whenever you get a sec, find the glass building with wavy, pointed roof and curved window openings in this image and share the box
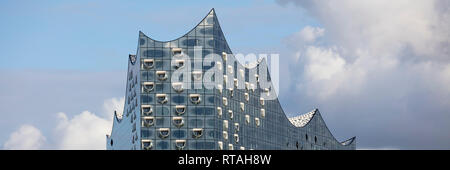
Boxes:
[106,9,355,150]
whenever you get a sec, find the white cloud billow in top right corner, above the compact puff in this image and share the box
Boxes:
[279,0,450,61]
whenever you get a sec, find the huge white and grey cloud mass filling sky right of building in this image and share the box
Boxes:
[278,0,450,148]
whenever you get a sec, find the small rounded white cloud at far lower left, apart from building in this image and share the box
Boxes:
[3,125,46,150]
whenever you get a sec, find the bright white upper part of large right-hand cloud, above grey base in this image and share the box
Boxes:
[278,0,450,99]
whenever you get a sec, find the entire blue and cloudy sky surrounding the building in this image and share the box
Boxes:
[0,0,450,149]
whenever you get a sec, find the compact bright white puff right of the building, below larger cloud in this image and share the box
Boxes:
[298,46,365,100]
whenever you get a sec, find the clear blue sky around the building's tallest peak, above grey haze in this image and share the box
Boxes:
[0,1,314,71]
